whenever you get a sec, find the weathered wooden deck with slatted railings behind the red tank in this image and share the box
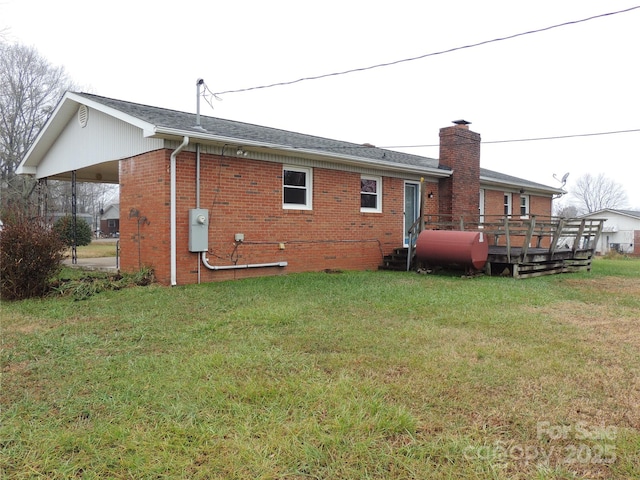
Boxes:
[408,215,605,278]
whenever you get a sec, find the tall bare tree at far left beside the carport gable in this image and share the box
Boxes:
[0,41,72,212]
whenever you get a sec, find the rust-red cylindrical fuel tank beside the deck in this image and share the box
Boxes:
[416,230,489,270]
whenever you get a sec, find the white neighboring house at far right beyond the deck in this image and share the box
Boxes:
[578,208,640,255]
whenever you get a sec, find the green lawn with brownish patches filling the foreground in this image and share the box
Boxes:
[0,259,640,479]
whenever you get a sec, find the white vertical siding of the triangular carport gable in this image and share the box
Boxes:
[37,108,164,178]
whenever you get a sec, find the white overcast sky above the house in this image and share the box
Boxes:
[5,0,640,210]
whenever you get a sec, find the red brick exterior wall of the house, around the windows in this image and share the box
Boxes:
[120,150,438,284]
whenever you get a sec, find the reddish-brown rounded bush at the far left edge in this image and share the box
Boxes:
[0,212,65,300]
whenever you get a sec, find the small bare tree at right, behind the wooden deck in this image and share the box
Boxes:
[571,173,627,213]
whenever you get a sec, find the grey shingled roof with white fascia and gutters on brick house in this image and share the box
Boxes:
[18,92,563,195]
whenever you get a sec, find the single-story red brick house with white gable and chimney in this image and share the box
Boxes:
[18,92,563,285]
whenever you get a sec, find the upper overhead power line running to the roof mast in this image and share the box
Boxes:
[213,5,640,97]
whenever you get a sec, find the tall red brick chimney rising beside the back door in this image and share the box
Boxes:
[439,120,480,222]
